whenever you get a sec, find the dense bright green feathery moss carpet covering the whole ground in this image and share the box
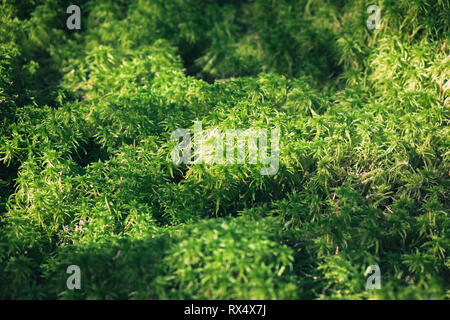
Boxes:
[0,0,450,299]
